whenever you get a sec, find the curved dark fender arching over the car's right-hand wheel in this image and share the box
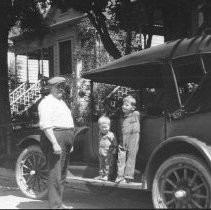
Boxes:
[143,136,211,189]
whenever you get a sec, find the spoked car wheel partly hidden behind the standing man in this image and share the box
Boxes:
[15,145,48,199]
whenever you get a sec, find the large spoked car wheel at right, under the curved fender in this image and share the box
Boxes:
[152,154,211,208]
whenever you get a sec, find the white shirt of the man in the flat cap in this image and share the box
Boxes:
[38,94,74,130]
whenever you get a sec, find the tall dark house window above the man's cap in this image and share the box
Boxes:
[59,40,72,75]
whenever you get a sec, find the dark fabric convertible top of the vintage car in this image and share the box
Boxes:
[83,35,211,88]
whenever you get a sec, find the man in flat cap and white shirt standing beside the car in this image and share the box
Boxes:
[38,77,74,209]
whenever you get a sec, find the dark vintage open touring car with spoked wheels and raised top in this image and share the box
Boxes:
[16,36,211,208]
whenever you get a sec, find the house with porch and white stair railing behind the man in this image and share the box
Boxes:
[10,7,85,113]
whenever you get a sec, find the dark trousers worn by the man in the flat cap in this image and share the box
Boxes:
[40,130,73,209]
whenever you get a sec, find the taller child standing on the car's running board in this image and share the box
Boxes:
[115,95,140,183]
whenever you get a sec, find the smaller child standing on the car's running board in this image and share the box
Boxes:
[95,116,117,181]
